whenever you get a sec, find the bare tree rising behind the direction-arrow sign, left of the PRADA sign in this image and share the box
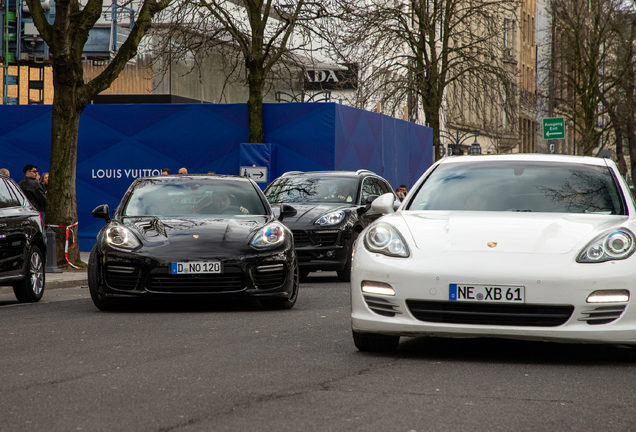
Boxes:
[152,0,325,143]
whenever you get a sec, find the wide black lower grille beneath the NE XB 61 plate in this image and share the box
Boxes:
[406,300,574,327]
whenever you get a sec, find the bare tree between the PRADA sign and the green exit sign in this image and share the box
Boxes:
[320,0,519,158]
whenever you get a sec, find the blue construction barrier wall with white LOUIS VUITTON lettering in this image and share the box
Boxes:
[0,103,433,251]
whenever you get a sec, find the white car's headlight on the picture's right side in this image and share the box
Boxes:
[576,228,636,263]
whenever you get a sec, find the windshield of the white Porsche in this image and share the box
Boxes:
[408,161,626,215]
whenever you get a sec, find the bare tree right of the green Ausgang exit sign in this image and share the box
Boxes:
[546,0,626,156]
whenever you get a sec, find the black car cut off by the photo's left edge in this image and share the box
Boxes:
[0,174,46,302]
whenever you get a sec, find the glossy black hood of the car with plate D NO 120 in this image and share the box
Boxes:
[118,216,267,254]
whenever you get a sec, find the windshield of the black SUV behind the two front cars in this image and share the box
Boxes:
[265,177,358,204]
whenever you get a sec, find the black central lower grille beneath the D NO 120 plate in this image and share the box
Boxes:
[146,271,247,294]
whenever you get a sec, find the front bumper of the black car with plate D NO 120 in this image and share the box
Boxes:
[98,249,294,298]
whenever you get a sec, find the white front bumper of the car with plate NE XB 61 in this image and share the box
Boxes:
[351,244,636,345]
